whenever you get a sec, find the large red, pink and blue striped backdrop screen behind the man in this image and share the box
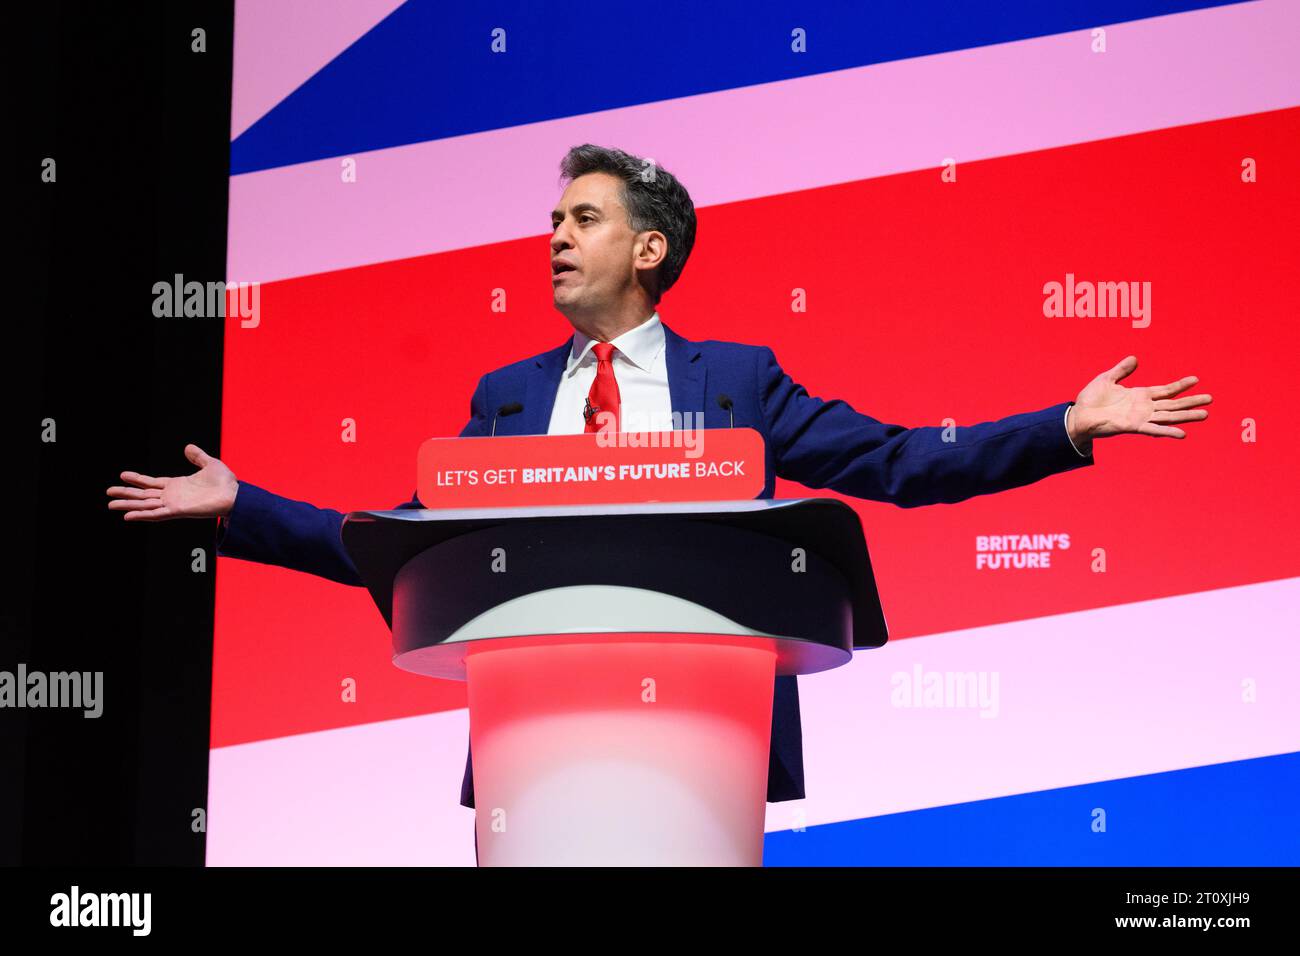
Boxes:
[208,0,1300,865]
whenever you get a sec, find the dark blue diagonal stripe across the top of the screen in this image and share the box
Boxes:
[230,0,1240,174]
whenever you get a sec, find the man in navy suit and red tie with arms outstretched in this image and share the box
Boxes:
[108,144,1210,868]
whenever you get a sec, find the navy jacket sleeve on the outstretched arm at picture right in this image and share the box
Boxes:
[757,347,1093,507]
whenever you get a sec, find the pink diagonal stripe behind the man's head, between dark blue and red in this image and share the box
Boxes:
[228,0,1300,282]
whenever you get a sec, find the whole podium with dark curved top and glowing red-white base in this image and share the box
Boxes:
[342,494,888,866]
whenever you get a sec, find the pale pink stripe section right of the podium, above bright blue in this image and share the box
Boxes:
[767,578,1300,830]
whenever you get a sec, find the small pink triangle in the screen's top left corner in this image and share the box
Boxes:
[230,0,403,139]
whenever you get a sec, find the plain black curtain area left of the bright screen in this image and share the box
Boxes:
[0,0,234,865]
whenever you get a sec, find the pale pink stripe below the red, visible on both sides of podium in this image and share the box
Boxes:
[208,578,1300,866]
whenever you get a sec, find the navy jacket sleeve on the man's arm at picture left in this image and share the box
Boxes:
[217,376,488,587]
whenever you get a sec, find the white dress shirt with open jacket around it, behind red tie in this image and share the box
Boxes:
[546,312,672,434]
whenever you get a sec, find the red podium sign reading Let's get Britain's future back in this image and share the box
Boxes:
[416,428,764,509]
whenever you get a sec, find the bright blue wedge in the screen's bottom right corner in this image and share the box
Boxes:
[763,753,1300,866]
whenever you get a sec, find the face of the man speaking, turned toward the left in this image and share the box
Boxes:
[551,173,645,319]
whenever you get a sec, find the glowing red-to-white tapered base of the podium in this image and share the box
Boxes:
[465,633,776,866]
